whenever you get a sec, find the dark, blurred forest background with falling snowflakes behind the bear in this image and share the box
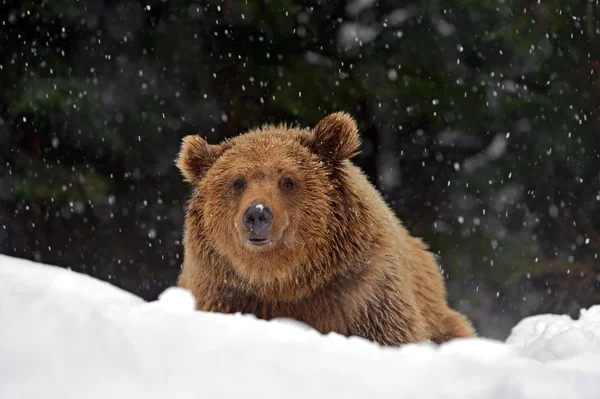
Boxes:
[0,0,600,338]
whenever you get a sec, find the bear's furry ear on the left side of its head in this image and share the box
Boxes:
[176,135,224,184]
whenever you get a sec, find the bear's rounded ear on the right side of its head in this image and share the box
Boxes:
[309,112,360,164]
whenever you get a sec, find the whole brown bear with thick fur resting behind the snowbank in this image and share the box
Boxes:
[177,113,474,346]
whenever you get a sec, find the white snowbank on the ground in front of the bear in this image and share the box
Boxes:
[0,255,600,399]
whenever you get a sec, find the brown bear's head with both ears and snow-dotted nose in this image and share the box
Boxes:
[177,112,360,294]
